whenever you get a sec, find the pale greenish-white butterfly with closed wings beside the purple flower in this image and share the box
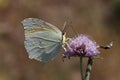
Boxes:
[22,18,67,62]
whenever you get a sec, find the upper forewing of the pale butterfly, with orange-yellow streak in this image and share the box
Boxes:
[22,18,61,34]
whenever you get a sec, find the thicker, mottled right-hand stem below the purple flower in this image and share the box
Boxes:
[84,57,93,80]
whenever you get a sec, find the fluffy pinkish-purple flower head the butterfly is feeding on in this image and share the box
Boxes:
[63,34,100,57]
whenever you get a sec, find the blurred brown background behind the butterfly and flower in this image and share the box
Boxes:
[0,0,120,80]
